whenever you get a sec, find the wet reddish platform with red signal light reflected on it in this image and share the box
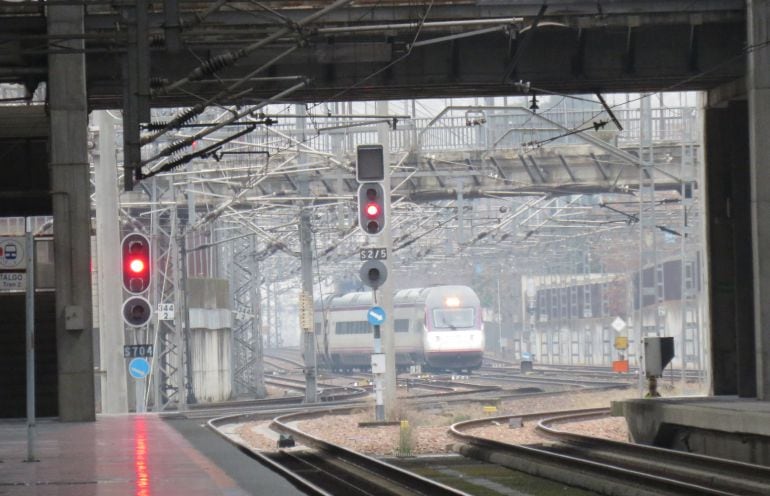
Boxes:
[0,414,303,496]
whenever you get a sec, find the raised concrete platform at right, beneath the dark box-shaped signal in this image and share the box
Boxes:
[613,396,770,466]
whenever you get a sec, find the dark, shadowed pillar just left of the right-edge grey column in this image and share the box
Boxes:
[704,102,756,397]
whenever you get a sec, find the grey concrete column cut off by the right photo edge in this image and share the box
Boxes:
[746,0,770,401]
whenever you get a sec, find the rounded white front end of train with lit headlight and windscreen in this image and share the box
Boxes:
[423,286,484,371]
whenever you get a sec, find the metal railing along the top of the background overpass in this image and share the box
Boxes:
[219,106,700,159]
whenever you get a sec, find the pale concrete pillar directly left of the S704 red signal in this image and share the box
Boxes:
[94,111,128,413]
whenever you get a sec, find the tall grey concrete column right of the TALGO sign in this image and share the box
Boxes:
[47,5,96,422]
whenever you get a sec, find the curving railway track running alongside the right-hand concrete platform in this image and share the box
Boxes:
[450,409,770,496]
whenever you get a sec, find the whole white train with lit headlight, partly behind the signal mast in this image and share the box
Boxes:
[315,286,484,371]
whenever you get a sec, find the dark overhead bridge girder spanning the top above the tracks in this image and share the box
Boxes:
[0,0,745,108]
